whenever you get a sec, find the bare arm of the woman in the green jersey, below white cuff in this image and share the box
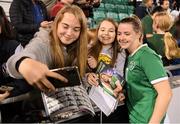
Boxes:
[149,80,172,123]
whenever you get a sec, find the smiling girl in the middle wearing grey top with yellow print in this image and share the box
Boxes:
[87,18,128,123]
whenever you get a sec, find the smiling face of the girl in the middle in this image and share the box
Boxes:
[98,21,116,45]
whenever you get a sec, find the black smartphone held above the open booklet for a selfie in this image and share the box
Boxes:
[48,66,81,88]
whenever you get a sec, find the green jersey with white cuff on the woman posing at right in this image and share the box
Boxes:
[125,44,168,123]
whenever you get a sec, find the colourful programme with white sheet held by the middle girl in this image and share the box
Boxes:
[89,61,125,116]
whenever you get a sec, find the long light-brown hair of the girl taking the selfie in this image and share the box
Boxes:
[50,5,87,76]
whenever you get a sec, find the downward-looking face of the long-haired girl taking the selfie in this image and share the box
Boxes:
[57,13,81,45]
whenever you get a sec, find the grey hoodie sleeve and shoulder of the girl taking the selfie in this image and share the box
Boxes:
[7,28,52,78]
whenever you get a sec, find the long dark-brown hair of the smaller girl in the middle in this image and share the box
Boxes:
[89,18,119,66]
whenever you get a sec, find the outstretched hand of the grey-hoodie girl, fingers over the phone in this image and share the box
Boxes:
[18,58,67,91]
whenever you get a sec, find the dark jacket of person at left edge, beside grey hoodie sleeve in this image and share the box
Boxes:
[0,38,32,97]
